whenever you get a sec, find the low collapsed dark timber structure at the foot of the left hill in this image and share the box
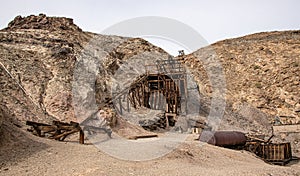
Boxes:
[26,121,84,144]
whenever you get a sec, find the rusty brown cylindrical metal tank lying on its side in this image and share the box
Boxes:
[199,131,247,147]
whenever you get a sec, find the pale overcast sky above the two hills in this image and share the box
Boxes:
[0,0,300,55]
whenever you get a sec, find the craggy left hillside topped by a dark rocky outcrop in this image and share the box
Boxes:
[0,14,168,125]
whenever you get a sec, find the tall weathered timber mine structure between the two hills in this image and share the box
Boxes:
[113,59,187,127]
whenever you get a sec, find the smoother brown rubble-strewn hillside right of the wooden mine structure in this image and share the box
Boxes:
[180,31,300,124]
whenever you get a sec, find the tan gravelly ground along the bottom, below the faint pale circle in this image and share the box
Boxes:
[0,124,300,176]
